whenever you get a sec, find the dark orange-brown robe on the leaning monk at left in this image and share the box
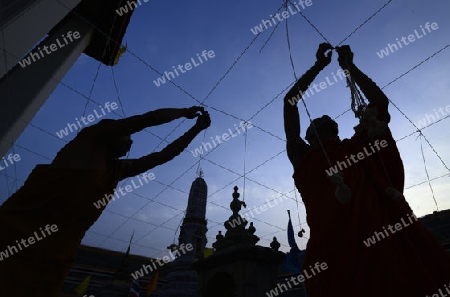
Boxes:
[0,162,121,297]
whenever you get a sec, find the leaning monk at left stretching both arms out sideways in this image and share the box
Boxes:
[0,106,211,297]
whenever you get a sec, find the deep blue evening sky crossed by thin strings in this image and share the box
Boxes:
[0,0,450,257]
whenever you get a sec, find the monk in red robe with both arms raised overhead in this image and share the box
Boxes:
[284,44,450,297]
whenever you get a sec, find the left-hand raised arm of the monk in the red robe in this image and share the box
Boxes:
[283,43,332,168]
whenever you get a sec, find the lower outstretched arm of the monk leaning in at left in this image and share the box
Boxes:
[119,111,211,179]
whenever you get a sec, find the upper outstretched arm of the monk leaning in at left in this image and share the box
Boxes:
[90,106,204,139]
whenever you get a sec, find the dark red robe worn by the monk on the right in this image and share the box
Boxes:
[293,104,450,297]
